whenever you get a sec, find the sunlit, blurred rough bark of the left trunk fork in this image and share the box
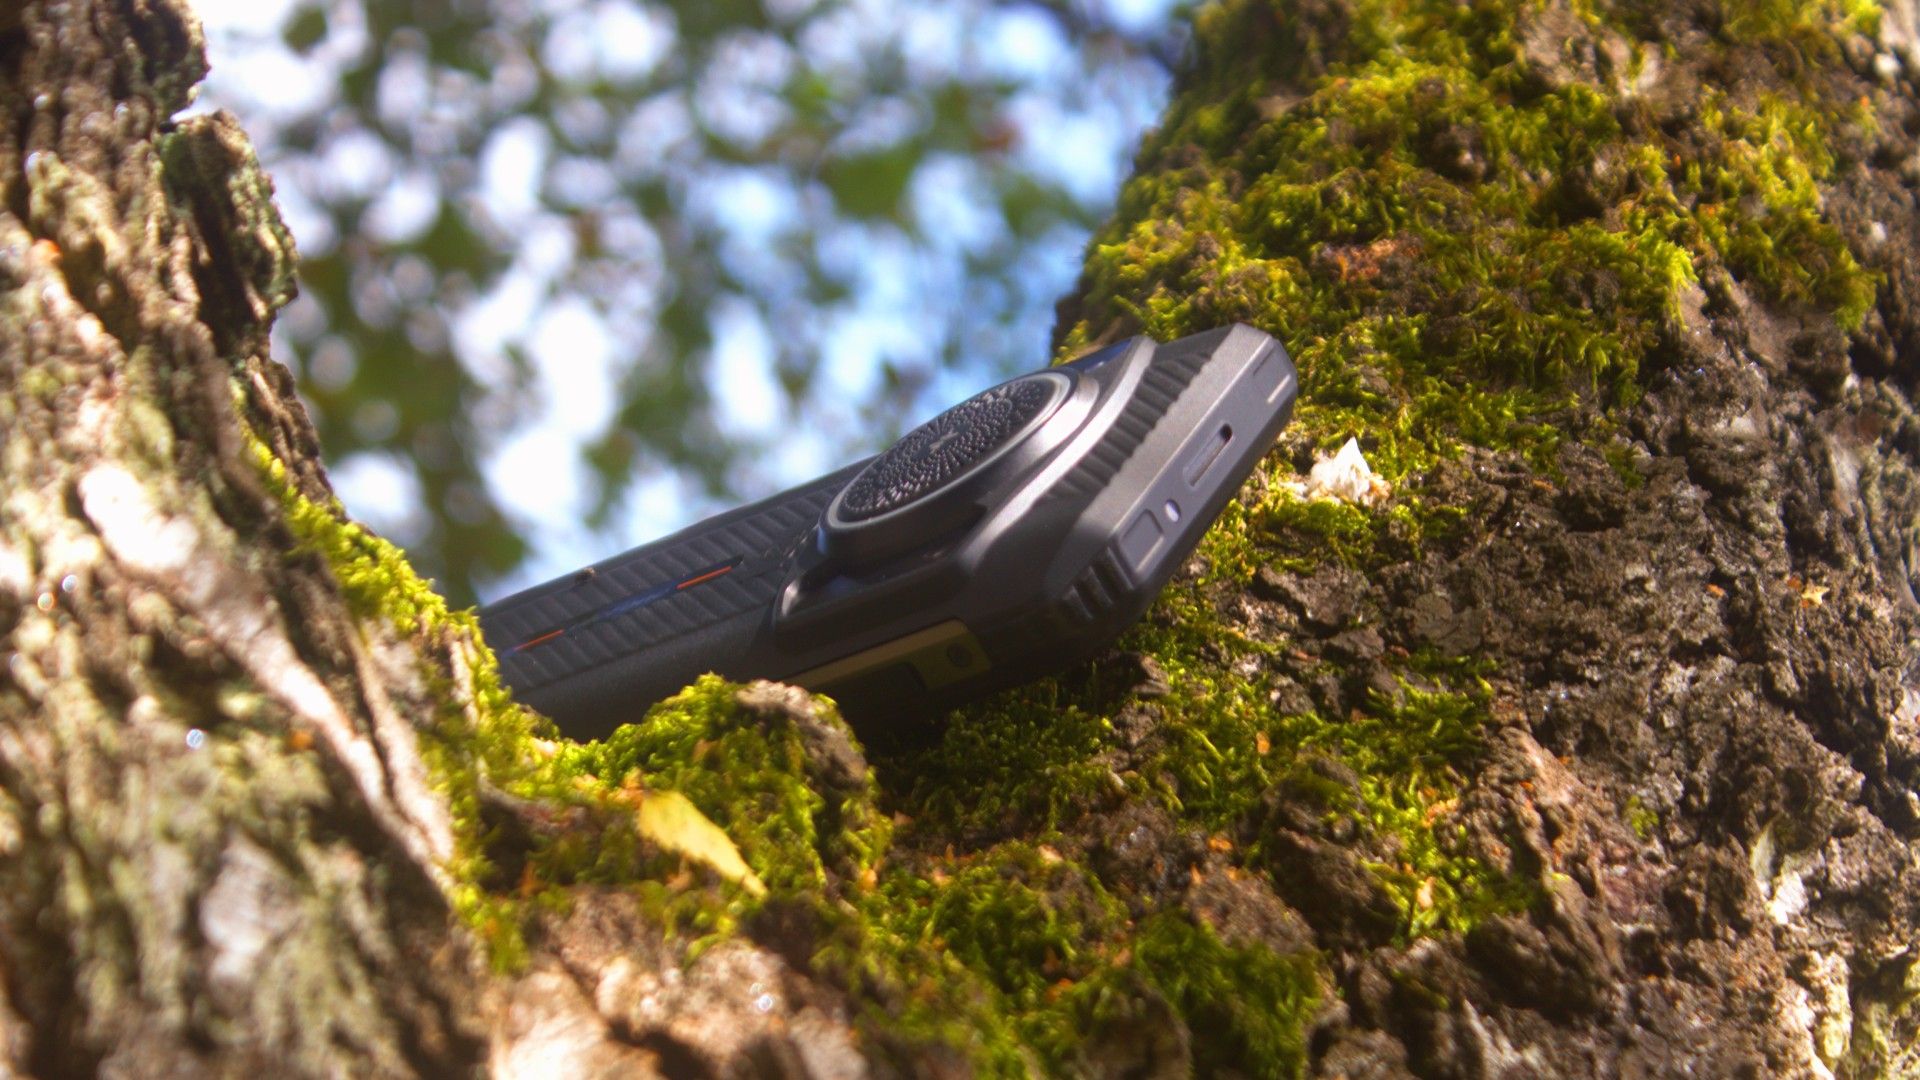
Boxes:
[0,2,503,1076]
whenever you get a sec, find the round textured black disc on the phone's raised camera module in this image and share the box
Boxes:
[835,373,1068,525]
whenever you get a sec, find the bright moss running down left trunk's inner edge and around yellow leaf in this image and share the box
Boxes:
[252,430,794,957]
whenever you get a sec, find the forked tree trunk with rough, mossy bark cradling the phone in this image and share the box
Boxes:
[0,0,1920,1076]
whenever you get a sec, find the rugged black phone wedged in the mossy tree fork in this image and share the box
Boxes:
[480,325,1296,742]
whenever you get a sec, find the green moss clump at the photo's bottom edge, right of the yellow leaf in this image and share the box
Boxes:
[818,842,1329,1076]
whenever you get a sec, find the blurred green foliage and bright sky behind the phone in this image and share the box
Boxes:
[211,0,1183,601]
